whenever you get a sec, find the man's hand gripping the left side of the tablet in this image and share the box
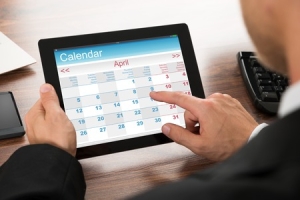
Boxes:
[25,84,76,156]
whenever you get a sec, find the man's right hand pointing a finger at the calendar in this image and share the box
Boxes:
[150,92,258,161]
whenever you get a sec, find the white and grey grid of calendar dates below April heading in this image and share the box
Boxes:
[61,62,190,147]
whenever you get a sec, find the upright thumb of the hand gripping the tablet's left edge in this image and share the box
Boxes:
[40,84,60,113]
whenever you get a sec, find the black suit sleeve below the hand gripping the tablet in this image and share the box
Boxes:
[0,144,86,200]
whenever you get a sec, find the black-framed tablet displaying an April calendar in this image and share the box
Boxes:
[39,24,204,158]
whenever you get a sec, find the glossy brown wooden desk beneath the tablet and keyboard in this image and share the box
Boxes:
[0,0,272,199]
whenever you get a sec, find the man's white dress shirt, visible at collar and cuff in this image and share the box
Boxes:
[248,81,300,142]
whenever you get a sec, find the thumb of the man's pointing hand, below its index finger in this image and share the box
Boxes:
[162,123,200,152]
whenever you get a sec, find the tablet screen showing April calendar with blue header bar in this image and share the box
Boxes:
[54,35,191,147]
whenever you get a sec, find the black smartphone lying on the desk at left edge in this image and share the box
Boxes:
[0,92,25,139]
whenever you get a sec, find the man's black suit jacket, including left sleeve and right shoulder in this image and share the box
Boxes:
[0,110,300,200]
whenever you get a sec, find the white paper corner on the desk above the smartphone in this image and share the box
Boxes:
[0,32,36,74]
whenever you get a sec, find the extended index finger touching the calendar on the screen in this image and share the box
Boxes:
[150,91,203,113]
